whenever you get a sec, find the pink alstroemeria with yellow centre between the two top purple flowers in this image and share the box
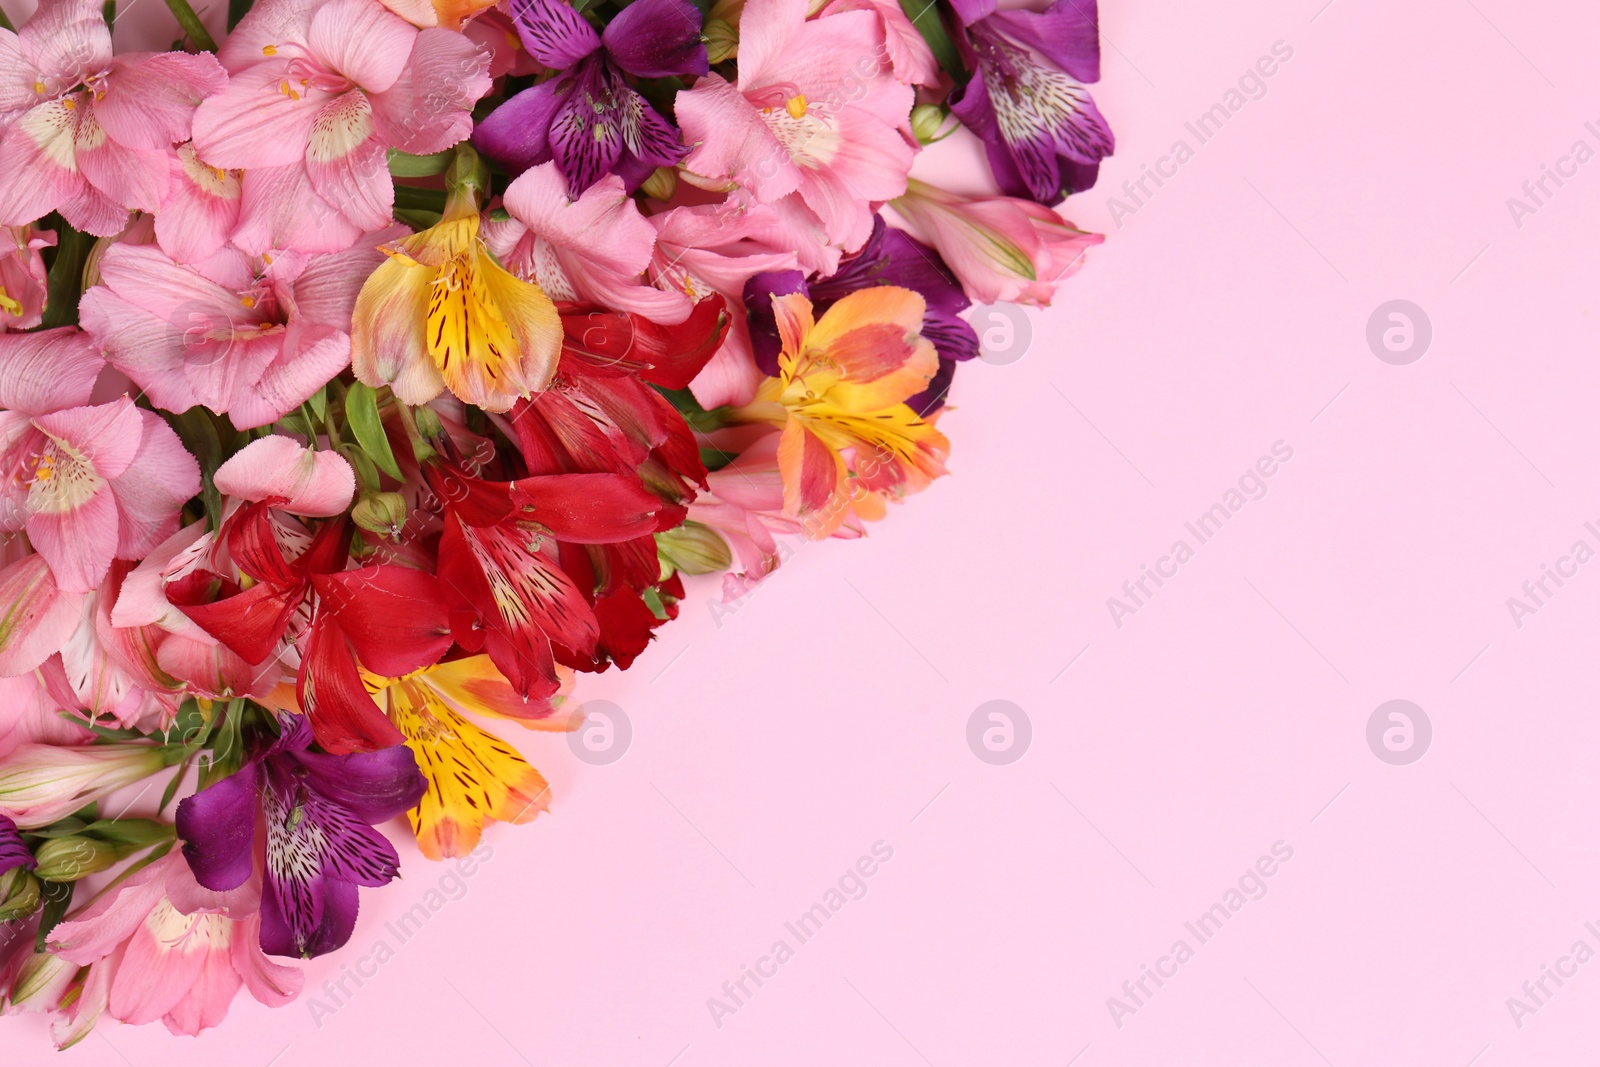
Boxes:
[677,0,917,251]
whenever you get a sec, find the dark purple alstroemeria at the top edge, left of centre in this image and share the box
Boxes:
[472,0,710,197]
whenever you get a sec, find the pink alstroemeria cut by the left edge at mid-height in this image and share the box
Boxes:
[0,328,200,592]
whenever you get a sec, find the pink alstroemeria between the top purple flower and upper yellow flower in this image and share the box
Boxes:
[482,162,694,326]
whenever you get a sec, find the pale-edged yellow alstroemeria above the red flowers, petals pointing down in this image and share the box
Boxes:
[350,197,562,411]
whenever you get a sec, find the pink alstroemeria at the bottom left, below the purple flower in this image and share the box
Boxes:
[50,853,306,1035]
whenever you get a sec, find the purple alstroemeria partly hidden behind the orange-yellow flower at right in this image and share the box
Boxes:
[744,216,978,414]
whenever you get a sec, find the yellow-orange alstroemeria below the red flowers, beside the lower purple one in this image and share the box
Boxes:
[363,656,576,859]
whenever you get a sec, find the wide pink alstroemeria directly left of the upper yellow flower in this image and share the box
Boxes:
[82,236,390,430]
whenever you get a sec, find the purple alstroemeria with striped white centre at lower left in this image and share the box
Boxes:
[178,712,427,958]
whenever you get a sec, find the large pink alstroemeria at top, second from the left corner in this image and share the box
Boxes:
[194,0,491,253]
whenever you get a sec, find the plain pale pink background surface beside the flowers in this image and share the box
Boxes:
[5,0,1600,1067]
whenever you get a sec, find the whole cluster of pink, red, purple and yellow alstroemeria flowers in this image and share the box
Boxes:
[0,0,1112,1046]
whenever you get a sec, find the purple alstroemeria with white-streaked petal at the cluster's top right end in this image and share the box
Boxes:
[950,0,1117,205]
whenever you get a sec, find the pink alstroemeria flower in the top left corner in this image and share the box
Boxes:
[0,0,227,237]
